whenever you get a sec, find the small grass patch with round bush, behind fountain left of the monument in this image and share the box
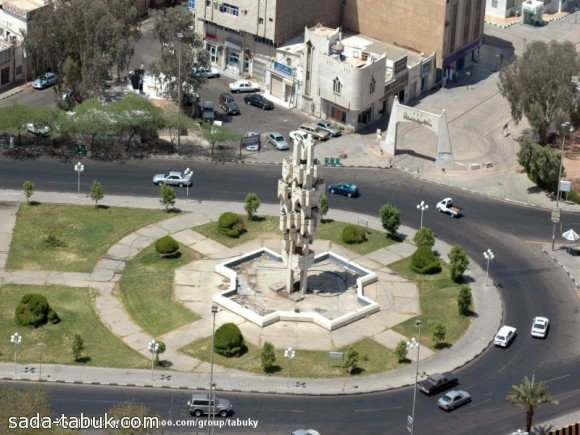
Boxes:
[193,216,282,248]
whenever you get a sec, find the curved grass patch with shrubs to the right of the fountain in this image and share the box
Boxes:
[389,257,471,349]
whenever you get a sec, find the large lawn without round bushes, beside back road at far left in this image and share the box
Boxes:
[6,204,167,273]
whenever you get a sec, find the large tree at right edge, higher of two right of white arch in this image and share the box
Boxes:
[498,40,580,143]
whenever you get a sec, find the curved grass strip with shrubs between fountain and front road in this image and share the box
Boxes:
[181,337,400,379]
